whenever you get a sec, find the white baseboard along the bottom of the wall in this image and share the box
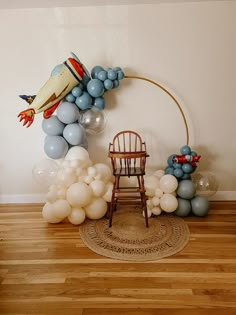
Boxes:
[0,191,236,204]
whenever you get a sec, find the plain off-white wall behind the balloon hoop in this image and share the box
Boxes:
[0,1,236,202]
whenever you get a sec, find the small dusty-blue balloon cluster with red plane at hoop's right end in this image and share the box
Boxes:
[165,145,201,180]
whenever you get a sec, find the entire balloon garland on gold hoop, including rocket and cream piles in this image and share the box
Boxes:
[18,53,218,224]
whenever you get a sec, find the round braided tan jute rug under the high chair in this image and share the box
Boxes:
[79,209,190,261]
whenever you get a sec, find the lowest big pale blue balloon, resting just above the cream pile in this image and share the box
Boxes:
[44,136,69,160]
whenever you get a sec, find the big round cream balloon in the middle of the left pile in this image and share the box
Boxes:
[66,182,93,207]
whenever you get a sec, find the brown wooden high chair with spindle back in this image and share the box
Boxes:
[108,130,148,227]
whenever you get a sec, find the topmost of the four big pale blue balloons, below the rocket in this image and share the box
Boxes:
[57,102,79,124]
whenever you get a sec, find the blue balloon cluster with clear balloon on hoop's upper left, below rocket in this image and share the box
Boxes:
[42,66,124,159]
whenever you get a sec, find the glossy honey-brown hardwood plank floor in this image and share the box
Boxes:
[0,201,236,315]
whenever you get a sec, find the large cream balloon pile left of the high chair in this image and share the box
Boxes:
[37,146,113,225]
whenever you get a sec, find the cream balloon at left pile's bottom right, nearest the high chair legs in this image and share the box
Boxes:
[84,198,107,220]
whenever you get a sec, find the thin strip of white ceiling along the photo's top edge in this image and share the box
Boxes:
[0,0,224,9]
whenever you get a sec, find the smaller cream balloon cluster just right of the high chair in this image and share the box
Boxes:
[144,170,178,217]
